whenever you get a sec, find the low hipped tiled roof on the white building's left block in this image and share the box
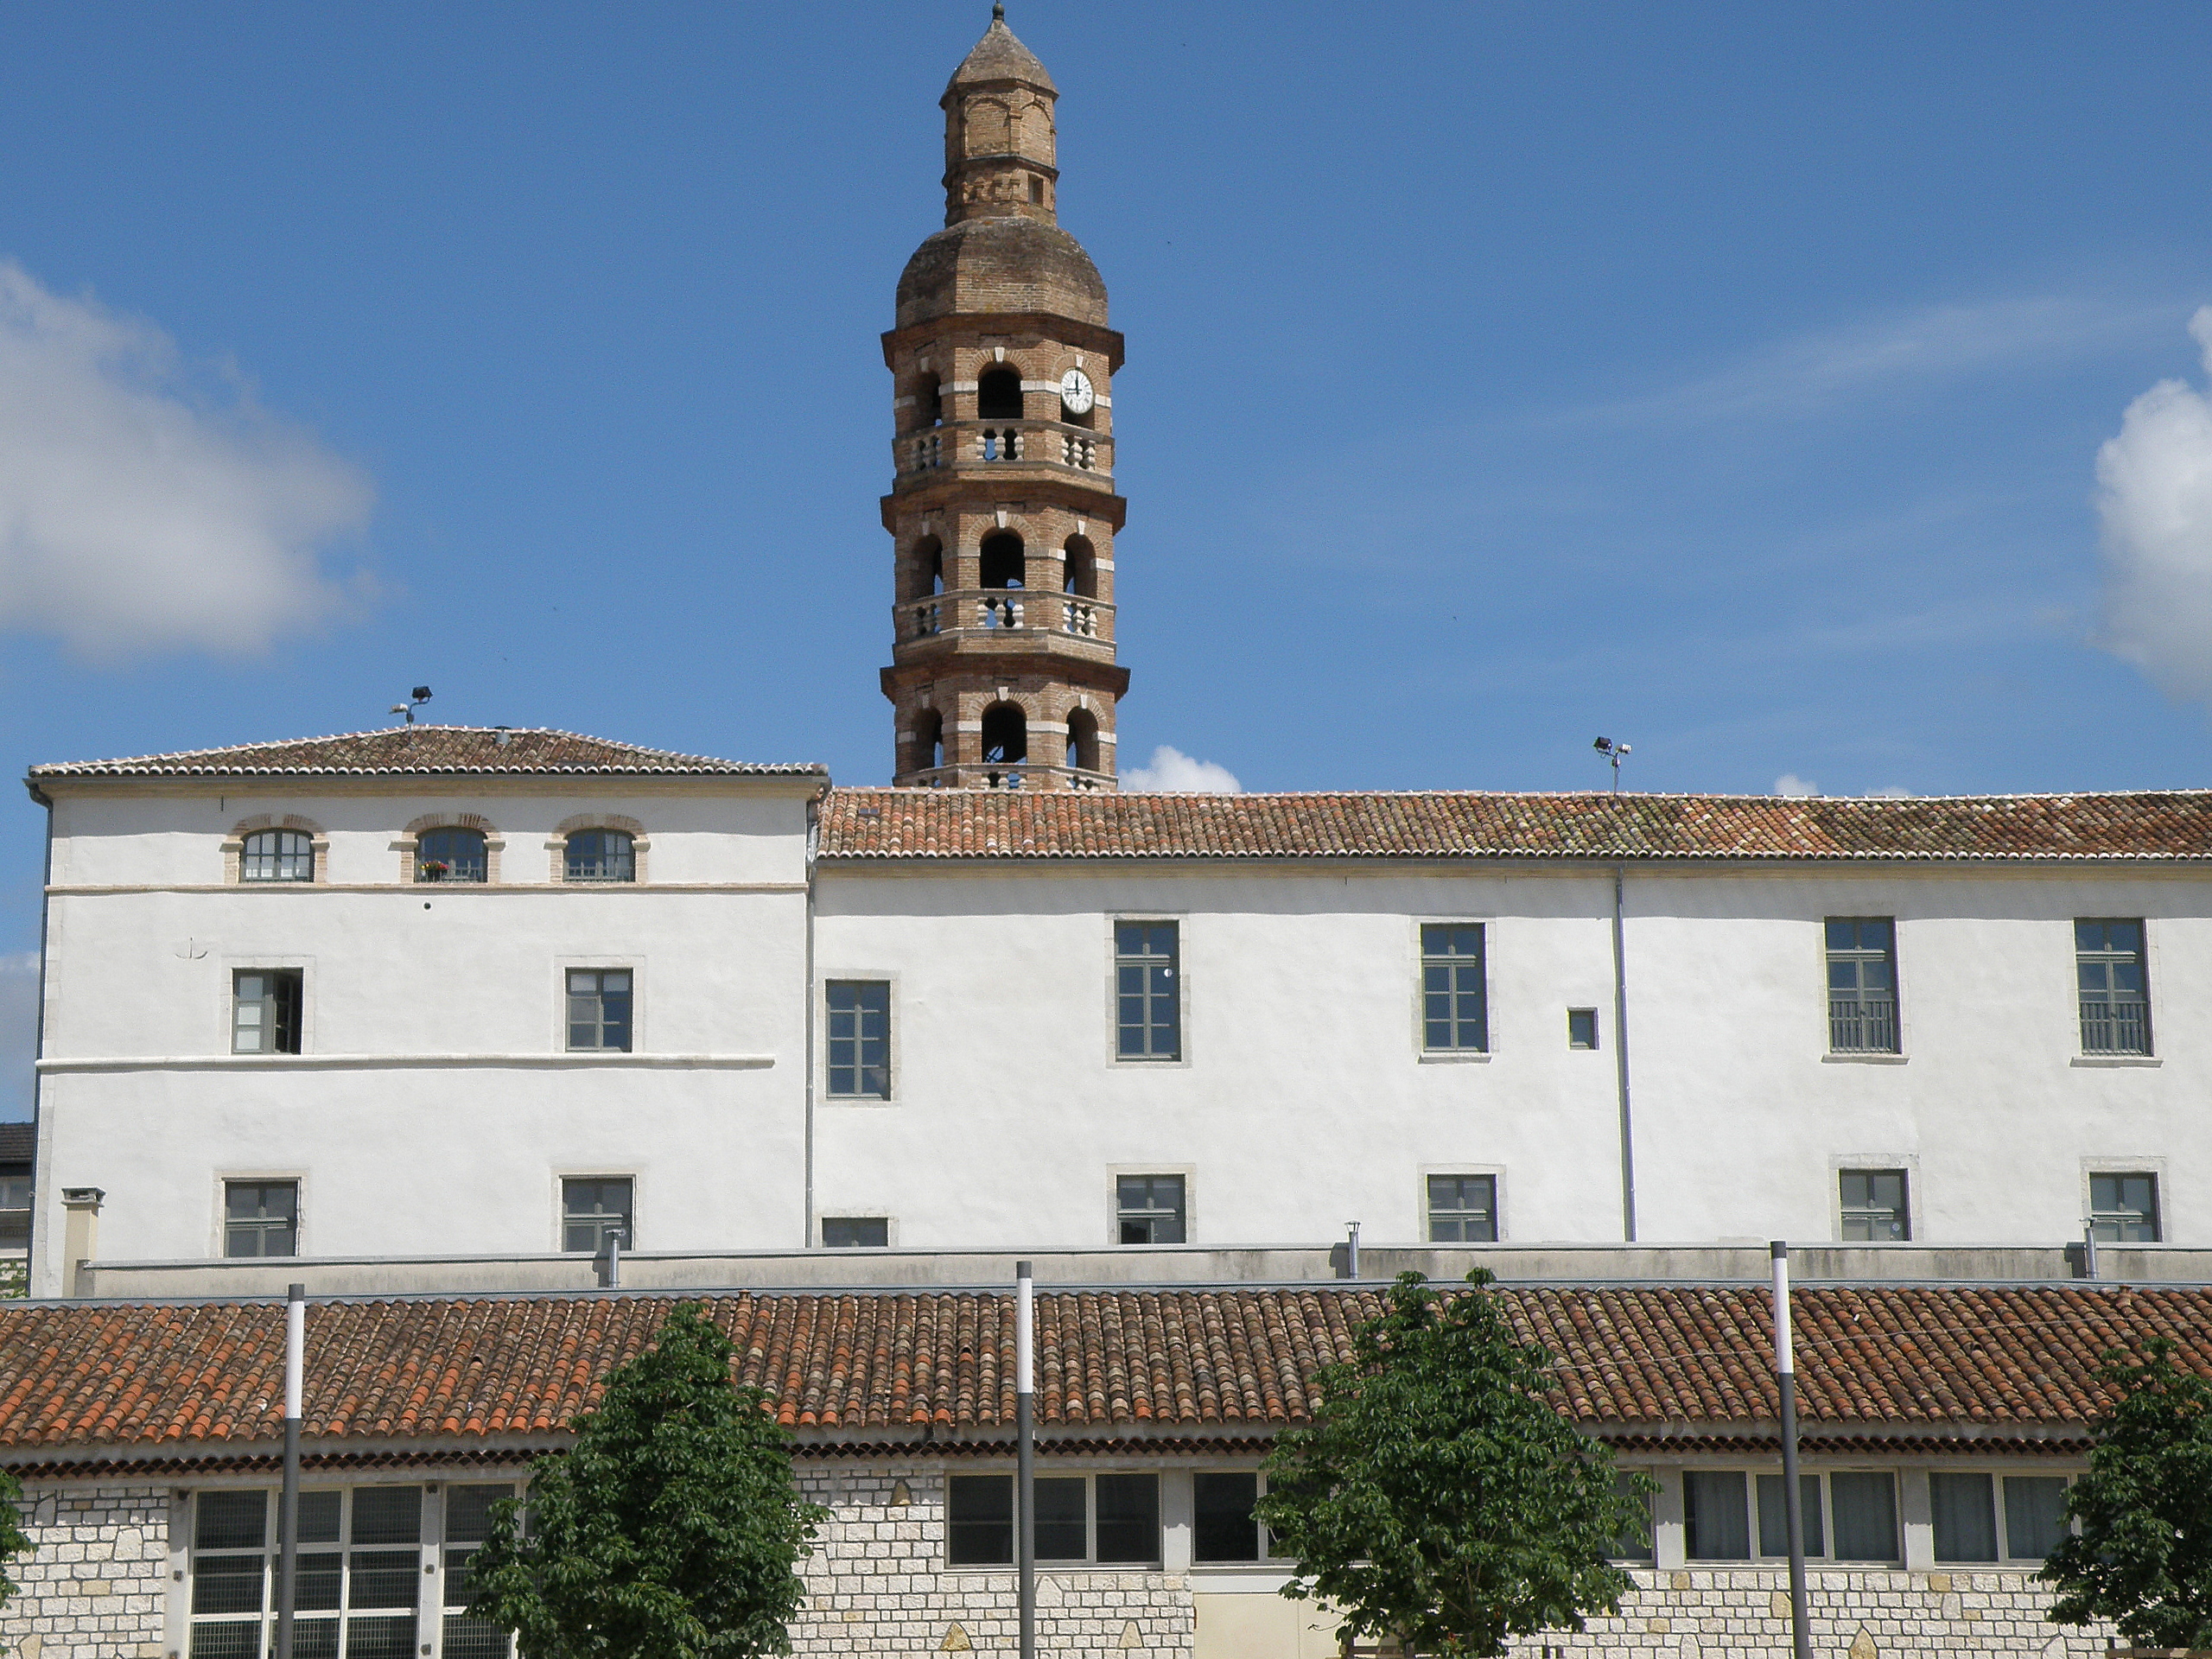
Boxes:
[31,726,827,783]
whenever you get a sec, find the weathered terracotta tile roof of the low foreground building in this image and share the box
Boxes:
[0,1285,2212,1462]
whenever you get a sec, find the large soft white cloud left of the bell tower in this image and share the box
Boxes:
[0,259,370,659]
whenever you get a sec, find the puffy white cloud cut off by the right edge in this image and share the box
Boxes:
[2097,305,2212,699]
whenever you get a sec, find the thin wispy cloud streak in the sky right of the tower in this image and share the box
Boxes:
[1580,294,2172,425]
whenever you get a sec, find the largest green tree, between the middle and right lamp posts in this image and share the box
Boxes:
[1259,1268,1656,1659]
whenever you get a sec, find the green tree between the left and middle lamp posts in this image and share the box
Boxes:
[469,1303,823,1659]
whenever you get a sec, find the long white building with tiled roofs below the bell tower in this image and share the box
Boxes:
[17,726,2212,1296]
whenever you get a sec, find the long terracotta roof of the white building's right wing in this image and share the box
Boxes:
[821,790,2212,861]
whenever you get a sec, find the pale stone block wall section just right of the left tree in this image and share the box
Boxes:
[791,1465,1192,1659]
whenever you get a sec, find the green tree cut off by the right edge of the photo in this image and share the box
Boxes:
[2037,1336,2212,1648]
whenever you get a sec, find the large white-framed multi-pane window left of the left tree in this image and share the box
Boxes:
[186,1486,467,1659]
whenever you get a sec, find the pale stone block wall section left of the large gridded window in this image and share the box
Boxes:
[0,1484,170,1659]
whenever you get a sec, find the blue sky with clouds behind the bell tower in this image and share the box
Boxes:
[0,0,2212,1110]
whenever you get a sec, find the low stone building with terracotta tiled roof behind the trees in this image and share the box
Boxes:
[0,1285,2141,1659]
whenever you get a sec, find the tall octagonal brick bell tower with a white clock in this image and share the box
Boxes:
[882,7,1128,790]
